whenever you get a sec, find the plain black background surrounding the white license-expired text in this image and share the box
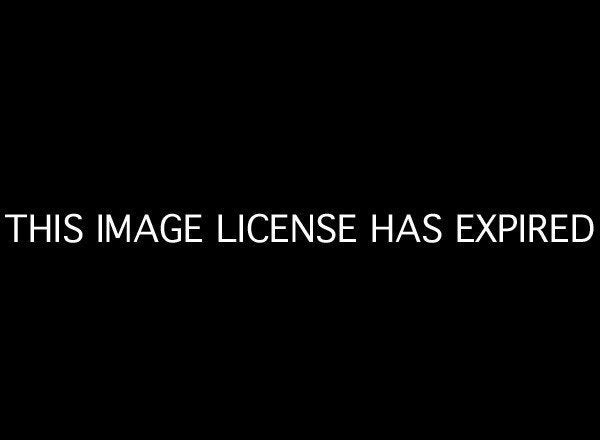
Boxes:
[1,5,598,433]
